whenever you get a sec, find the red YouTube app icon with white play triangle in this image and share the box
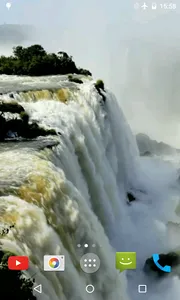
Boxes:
[8,256,29,271]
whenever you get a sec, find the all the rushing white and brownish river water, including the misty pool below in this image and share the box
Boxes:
[0,75,180,300]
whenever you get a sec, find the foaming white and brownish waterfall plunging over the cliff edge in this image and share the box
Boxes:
[0,79,136,300]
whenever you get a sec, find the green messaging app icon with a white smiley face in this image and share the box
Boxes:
[116,252,136,272]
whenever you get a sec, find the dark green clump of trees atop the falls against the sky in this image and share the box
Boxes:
[0,44,92,76]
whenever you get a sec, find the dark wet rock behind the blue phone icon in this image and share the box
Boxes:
[144,252,180,277]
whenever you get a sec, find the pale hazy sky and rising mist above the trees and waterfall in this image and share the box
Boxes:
[0,0,180,146]
